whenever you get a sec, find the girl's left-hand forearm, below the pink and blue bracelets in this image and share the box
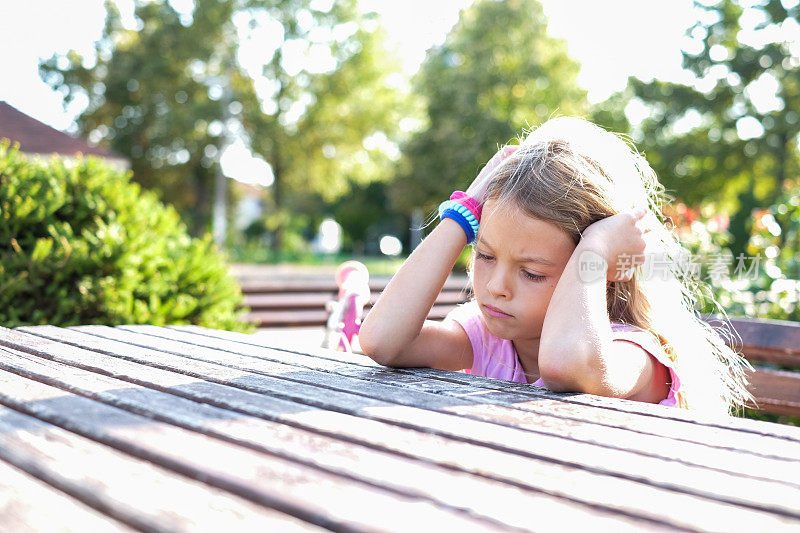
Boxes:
[358,218,467,365]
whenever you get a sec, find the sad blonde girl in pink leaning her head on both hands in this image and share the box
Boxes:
[359,118,750,413]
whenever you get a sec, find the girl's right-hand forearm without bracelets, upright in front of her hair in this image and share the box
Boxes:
[538,241,611,394]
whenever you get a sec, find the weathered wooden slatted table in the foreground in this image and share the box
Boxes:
[0,326,800,532]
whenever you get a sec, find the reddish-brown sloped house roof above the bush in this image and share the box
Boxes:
[0,101,125,160]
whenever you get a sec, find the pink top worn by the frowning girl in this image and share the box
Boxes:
[447,302,681,407]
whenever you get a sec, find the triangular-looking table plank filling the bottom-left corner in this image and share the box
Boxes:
[0,456,135,533]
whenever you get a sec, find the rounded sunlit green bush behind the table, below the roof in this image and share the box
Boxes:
[0,142,249,331]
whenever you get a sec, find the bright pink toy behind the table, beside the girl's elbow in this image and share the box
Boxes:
[325,261,370,352]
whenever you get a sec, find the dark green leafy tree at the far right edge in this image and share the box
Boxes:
[630,0,800,254]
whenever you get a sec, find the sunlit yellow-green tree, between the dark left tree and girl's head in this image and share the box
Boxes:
[238,14,412,249]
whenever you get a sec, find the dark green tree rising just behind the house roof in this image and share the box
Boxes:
[40,0,234,233]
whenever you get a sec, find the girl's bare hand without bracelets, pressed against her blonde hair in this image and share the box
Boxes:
[581,207,652,281]
